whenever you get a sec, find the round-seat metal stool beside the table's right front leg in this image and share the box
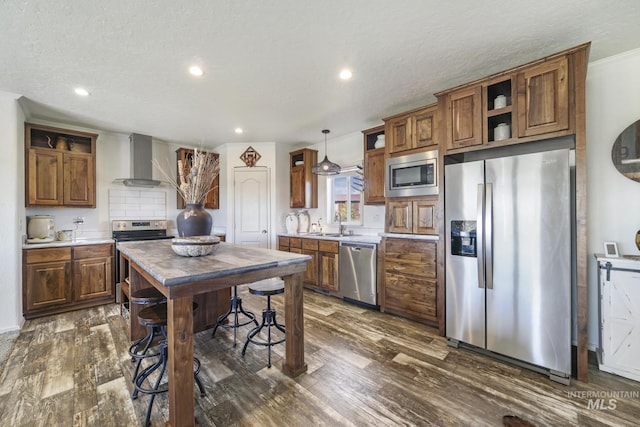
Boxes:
[242,277,285,368]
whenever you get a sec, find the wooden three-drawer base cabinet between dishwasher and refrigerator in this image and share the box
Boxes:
[380,238,440,324]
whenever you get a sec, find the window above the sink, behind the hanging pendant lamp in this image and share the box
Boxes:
[327,173,362,225]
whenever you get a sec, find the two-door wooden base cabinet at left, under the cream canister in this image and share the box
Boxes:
[22,244,115,319]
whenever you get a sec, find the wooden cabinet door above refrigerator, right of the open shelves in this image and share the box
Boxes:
[517,57,569,137]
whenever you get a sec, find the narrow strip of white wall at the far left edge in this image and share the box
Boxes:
[0,92,25,333]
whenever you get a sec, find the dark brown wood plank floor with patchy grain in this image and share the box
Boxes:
[0,288,640,427]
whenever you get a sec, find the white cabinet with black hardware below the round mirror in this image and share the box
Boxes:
[597,256,640,381]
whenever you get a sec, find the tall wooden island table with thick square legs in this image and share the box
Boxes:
[118,240,311,426]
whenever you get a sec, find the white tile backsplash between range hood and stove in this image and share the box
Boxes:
[109,188,167,221]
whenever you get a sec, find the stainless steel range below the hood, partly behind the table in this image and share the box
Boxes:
[111,219,173,309]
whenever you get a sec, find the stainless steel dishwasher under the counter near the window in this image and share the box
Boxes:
[338,242,378,306]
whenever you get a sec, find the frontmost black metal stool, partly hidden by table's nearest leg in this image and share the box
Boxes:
[131,302,205,426]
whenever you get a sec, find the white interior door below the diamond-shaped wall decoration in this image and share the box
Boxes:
[233,168,270,248]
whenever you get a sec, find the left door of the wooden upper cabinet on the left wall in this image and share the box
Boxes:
[26,149,64,206]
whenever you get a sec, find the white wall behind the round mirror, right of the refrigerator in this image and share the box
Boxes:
[587,49,640,349]
